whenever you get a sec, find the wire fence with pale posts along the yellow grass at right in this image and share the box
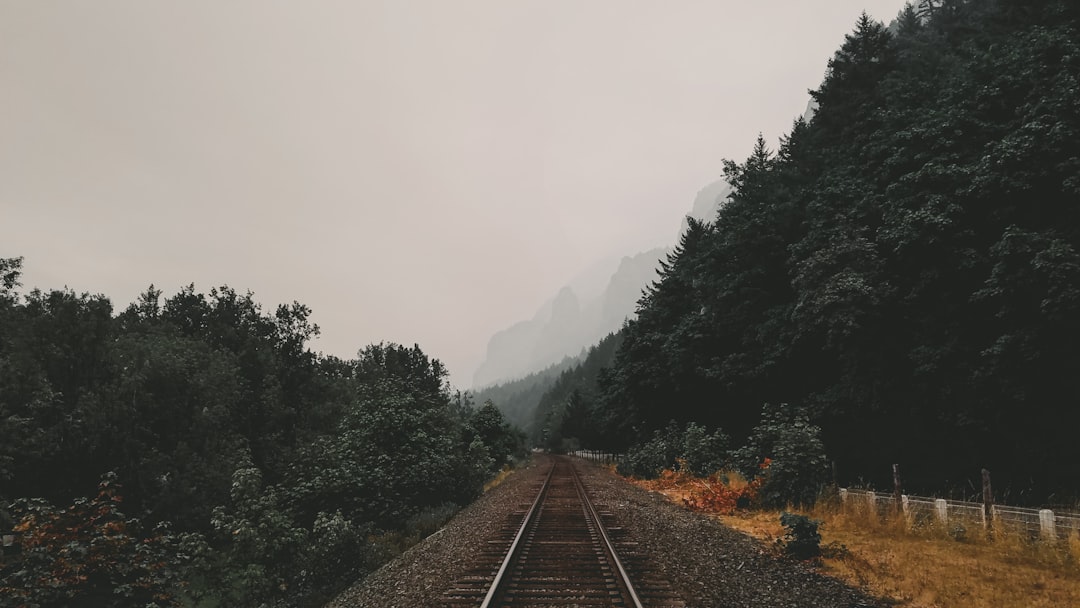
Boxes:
[840,488,1080,540]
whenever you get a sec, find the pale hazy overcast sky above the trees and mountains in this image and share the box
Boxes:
[0,0,903,388]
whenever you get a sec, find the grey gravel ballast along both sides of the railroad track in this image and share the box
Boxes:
[327,456,889,608]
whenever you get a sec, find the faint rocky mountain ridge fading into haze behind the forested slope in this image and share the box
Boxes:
[472,181,731,390]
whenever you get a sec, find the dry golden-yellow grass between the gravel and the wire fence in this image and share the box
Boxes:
[719,498,1080,608]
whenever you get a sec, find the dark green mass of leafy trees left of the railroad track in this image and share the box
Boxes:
[0,258,524,607]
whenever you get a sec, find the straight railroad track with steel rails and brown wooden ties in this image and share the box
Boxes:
[443,457,684,608]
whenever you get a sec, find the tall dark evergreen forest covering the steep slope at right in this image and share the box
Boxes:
[529,0,1080,502]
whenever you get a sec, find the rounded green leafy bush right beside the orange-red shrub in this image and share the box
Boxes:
[732,404,828,508]
